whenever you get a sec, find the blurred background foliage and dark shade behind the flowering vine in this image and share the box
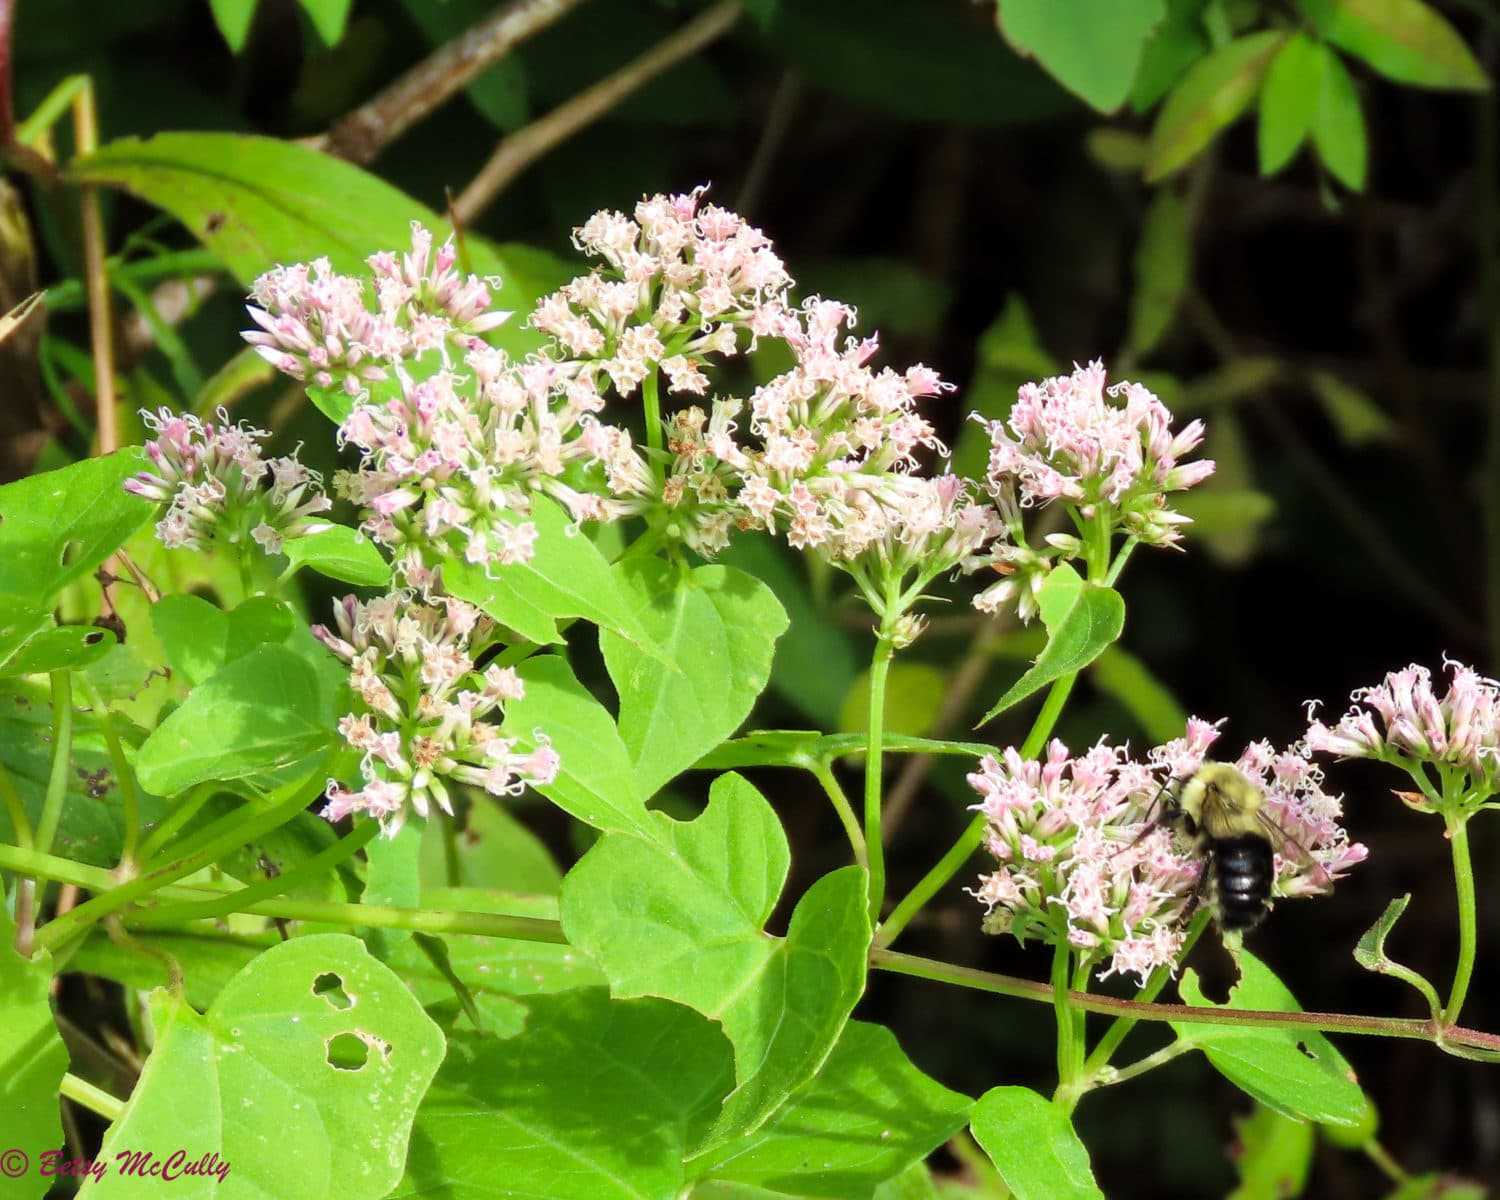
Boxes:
[0,0,1500,1200]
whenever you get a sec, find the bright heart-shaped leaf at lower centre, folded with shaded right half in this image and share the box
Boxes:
[563,776,870,1149]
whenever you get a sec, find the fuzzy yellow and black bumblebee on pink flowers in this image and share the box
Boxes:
[1160,762,1308,933]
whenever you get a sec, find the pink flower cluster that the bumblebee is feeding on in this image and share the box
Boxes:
[969,720,1367,984]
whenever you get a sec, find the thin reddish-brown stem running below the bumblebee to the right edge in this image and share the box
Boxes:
[870,950,1500,1058]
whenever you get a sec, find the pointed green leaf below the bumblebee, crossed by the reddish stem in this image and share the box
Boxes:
[1172,950,1370,1125]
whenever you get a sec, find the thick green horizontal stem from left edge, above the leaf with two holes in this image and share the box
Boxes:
[0,846,567,945]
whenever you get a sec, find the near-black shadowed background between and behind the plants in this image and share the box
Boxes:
[0,0,1500,1200]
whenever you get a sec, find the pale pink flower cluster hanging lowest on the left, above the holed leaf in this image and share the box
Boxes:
[312,593,560,837]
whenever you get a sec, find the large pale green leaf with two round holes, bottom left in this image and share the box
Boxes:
[81,933,444,1200]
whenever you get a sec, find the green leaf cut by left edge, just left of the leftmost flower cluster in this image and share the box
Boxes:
[0,447,155,605]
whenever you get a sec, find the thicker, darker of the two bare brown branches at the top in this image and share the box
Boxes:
[322,0,584,167]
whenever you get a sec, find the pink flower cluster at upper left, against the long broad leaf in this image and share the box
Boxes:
[245,222,510,396]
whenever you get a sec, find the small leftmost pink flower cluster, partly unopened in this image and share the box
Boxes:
[125,408,333,554]
